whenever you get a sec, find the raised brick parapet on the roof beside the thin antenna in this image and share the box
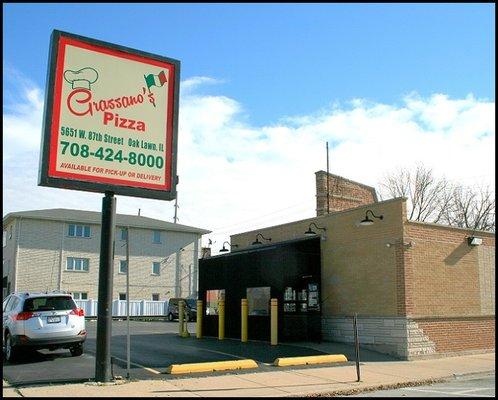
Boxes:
[315,171,377,216]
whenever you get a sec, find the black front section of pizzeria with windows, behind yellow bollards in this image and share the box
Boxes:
[199,237,321,341]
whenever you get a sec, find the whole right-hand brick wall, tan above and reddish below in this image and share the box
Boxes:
[400,221,495,356]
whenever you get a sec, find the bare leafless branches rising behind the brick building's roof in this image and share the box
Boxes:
[380,165,495,232]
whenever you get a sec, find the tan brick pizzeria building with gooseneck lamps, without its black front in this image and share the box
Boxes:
[200,171,495,359]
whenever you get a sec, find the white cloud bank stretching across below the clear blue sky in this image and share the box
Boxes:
[3,70,495,253]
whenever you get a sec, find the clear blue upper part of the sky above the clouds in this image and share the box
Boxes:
[3,3,495,124]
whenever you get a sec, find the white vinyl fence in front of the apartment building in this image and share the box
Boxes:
[74,299,168,317]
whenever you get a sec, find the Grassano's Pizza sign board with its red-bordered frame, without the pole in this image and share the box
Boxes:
[38,30,180,200]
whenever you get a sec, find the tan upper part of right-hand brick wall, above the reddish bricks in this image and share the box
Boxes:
[404,222,495,317]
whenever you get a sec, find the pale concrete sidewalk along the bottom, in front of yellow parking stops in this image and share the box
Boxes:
[3,352,495,397]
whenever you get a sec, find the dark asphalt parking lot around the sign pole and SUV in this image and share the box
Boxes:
[3,321,372,386]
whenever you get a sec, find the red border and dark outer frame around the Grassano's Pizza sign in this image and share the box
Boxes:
[38,30,180,200]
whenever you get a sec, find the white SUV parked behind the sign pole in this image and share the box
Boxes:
[2,292,86,361]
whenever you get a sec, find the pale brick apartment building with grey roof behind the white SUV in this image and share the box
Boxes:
[3,209,209,301]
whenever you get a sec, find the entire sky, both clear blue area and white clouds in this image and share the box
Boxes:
[3,3,495,254]
